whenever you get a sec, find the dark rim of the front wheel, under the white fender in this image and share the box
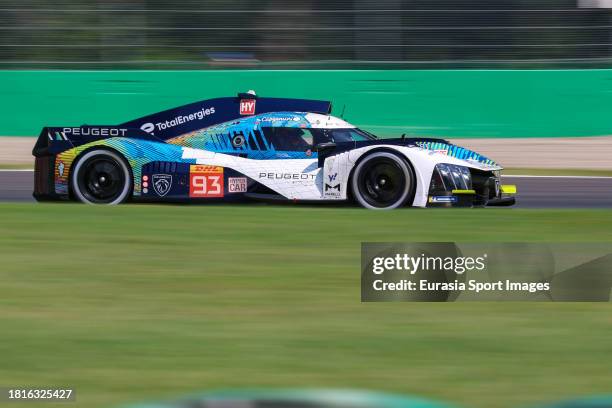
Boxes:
[358,157,406,208]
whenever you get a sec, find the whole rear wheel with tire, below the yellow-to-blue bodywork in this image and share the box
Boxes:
[70,149,133,205]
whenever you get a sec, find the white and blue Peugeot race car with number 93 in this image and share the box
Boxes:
[33,92,516,209]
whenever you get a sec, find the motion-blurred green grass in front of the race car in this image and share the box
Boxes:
[0,204,612,408]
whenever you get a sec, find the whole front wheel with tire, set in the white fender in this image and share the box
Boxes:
[351,151,416,210]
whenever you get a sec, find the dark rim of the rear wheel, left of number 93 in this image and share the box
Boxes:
[77,156,125,204]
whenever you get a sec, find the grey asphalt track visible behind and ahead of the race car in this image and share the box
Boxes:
[0,170,612,208]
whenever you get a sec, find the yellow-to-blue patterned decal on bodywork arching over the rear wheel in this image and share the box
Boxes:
[55,137,190,196]
